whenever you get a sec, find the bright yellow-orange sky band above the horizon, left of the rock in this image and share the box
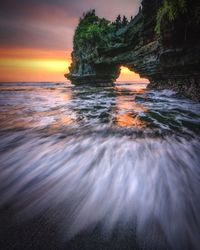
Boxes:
[0,48,71,82]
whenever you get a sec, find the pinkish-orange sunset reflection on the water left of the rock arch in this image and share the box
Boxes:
[0,84,74,130]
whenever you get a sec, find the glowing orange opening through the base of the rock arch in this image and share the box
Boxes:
[117,66,149,83]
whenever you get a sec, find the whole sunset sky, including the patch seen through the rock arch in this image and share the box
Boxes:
[0,0,147,82]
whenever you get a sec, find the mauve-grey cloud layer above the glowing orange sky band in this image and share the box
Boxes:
[0,0,140,49]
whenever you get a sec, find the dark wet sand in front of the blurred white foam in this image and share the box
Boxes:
[0,206,169,250]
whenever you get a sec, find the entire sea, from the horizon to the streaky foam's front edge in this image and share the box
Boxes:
[0,83,200,250]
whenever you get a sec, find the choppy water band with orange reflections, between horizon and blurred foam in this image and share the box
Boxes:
[0,83,200,134]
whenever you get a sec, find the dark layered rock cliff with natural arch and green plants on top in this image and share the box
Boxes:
[65,0,200,101]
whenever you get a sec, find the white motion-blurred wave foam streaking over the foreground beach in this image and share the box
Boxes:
[0,130,200,250]
